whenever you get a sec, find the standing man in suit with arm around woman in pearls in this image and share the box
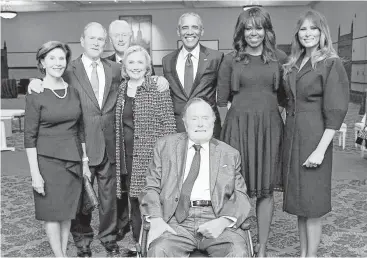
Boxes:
[29,22,121,257]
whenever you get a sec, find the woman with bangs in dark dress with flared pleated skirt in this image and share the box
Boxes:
[218,7,286,256]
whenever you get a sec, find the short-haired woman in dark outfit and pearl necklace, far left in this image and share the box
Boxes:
[24,41,90,257]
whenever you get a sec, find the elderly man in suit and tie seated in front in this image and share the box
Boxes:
[140,98,250,257]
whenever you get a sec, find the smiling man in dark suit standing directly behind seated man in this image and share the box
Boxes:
[162,13,223,138]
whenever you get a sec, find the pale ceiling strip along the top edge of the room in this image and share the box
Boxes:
[1,0,317,12]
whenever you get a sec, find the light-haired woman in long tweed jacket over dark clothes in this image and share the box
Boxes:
[115,46,176,246]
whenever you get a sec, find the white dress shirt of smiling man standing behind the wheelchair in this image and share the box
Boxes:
[176,44,200,87]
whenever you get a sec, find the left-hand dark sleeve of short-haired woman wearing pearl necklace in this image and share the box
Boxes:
[24,93,42,148]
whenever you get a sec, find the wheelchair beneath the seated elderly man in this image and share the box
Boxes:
[136,218,254,258]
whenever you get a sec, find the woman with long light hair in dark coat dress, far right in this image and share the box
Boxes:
[283,10,349,257]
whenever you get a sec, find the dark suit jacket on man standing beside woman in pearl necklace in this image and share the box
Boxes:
[63,57,121,166]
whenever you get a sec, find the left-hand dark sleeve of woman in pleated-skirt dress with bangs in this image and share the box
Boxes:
[217,53,233,107]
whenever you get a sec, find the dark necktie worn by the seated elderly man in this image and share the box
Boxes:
[175,144,201,223]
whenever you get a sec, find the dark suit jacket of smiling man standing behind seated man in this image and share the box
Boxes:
[162,45,223,138]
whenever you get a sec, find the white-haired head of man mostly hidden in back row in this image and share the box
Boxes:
[108,20,132,57]
